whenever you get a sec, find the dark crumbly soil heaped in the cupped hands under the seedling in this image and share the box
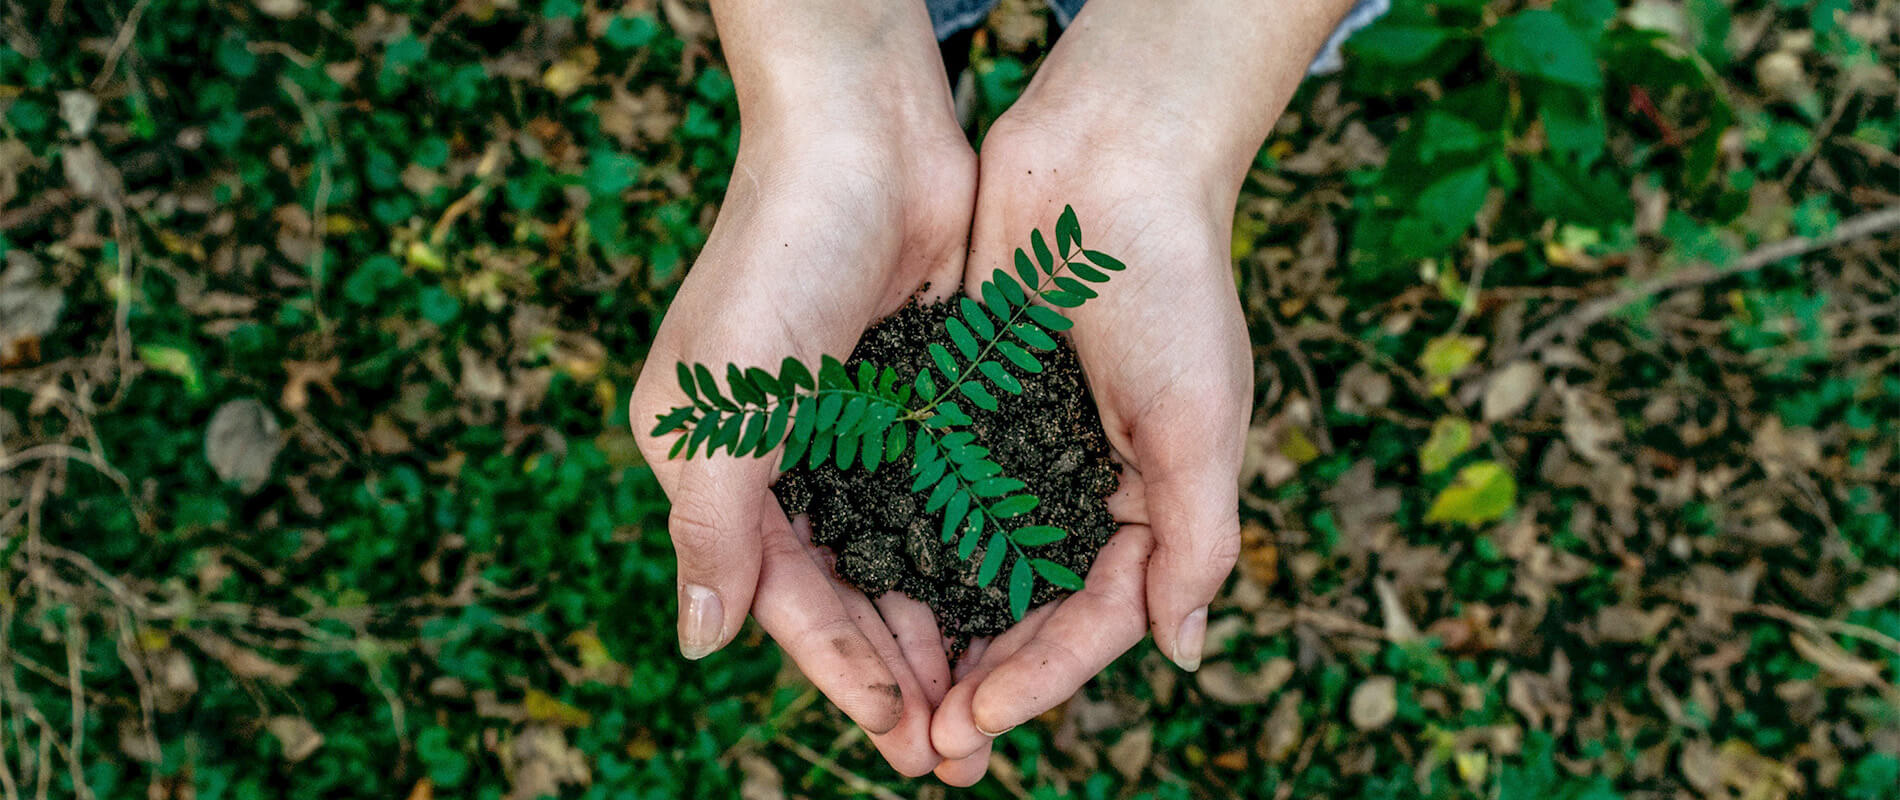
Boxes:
[773,302,1119,654]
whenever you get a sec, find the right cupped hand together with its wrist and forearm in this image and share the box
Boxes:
[931,0,1343,785]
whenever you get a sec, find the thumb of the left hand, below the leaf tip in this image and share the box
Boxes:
[667,458,763,659]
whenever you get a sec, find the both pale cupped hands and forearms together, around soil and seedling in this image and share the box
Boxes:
[631,0,1351,785]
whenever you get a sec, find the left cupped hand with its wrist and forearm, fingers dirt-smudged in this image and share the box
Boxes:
[631,2,975,775]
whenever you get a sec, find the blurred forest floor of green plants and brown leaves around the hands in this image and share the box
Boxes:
[0,0,1900,800]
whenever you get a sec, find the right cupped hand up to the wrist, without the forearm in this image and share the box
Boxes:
[933,101,1252,785]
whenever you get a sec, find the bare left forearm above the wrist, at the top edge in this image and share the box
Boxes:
[713,0,950,134]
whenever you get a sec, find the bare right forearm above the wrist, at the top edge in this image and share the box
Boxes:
[1024,0,1353,186]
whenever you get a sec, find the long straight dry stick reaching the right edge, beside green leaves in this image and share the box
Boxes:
[1497,205,1900,365]
